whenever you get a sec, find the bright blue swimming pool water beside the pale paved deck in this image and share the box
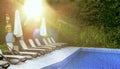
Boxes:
[43,48,120,69]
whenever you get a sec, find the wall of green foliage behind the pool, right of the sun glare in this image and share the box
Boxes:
[47,0,120,48]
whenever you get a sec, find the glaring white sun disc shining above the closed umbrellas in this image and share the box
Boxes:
[23,0,43,18]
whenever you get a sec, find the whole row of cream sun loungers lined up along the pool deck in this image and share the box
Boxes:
[0,37,67,69]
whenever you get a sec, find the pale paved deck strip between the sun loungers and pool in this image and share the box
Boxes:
[8,46,80,69]
